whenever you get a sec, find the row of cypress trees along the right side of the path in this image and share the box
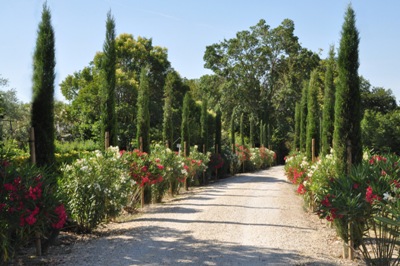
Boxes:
[294,5,362,175]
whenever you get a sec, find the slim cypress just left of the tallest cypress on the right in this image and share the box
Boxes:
[321,46,335,156]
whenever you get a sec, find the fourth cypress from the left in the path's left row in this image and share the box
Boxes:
[163,72,175,148]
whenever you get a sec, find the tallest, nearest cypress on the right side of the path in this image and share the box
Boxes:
[333,5,362,175]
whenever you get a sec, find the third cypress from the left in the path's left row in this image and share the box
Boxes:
[136,67,150,153]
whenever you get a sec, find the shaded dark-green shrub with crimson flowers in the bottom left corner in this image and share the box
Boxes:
[0,160,67,262]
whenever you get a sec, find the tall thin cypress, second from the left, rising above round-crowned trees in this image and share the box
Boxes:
[100,11,118,149]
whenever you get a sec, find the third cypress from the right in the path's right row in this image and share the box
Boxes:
[306,70,320,160]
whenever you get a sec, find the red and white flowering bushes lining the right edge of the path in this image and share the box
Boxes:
[285,153,400,265]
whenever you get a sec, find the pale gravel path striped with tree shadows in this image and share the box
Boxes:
[54,166,359,265]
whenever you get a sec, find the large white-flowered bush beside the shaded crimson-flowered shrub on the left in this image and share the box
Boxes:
[59,147,133,232]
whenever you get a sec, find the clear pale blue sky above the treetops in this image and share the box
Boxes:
[0,0,400,102]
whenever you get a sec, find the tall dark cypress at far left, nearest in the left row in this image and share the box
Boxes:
[31,3,56,166]
